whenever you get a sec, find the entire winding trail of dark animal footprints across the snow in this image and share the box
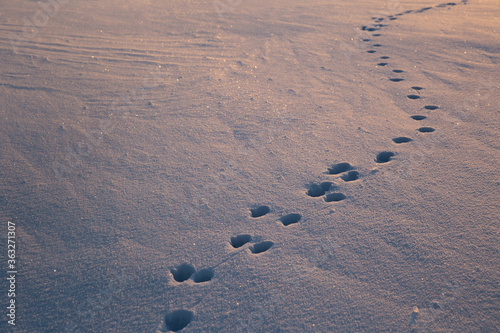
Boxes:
[158,0,468,332]
